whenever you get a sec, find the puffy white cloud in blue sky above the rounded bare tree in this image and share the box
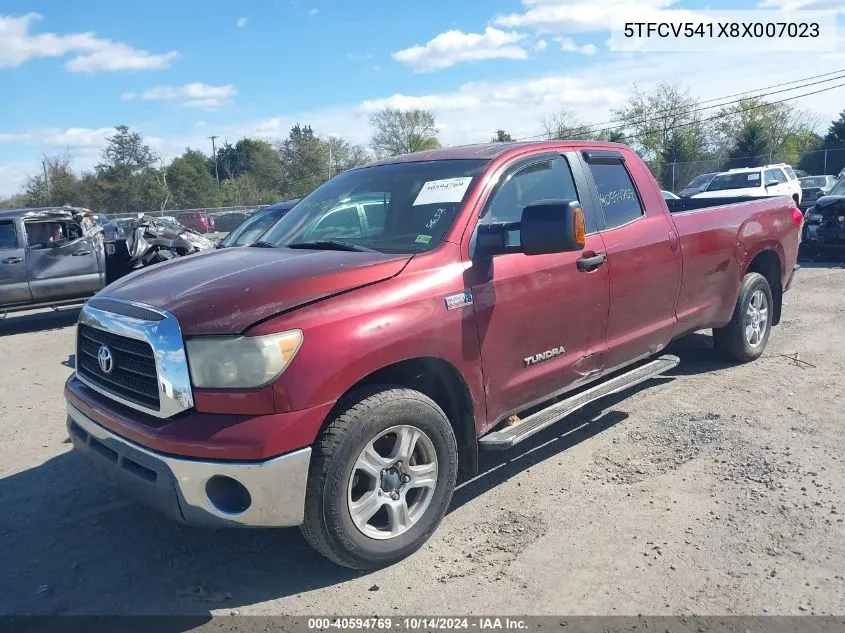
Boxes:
[393,27,528,72]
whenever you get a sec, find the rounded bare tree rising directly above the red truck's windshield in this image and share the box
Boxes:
[370,108,440,156]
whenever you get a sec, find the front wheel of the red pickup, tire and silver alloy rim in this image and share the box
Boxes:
[300,385,458,569]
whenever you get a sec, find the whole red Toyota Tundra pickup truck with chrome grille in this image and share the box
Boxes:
[65,141,802,568]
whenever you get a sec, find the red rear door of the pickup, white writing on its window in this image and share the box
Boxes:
[582,151,681,370]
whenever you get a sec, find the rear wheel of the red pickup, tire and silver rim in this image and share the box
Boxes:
[713,273,774,363]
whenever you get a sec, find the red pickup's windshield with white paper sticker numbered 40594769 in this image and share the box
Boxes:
[261,159,488,253]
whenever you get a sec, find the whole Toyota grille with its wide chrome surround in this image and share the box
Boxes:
[76,297,194,418]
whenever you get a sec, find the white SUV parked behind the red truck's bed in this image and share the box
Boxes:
[693,163,801,204]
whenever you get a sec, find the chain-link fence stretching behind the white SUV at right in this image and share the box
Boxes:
[652,148,845,193]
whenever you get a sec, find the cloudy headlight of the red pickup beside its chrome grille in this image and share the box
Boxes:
[185,330,302,389]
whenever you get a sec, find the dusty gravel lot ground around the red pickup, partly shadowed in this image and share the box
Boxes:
[0,265,845,615]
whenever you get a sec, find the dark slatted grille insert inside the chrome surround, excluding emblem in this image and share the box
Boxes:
[76,323,159,411]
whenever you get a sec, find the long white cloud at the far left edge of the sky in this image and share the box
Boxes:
[0,13,179,72]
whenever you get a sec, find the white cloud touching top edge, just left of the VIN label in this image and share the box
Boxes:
[494,0,677,33]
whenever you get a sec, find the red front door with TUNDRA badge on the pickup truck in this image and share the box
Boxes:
[467,154,610,423]
